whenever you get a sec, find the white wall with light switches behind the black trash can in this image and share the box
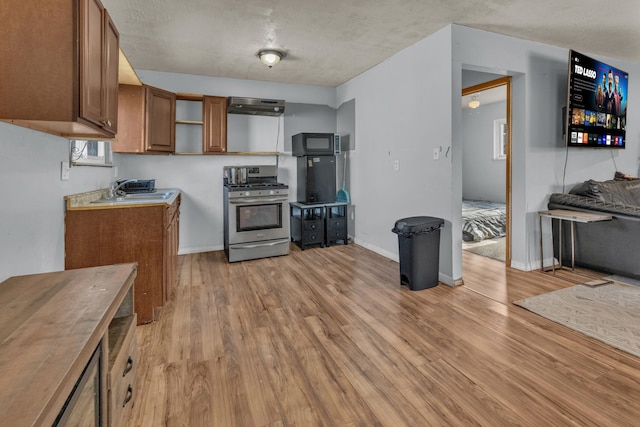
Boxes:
[337,27,461,283]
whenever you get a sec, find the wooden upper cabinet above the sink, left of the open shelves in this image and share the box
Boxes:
[111,85,176,153]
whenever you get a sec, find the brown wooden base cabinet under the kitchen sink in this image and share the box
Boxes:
[65,195,180,324]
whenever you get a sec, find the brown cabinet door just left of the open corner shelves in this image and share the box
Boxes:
[144,86,176,153]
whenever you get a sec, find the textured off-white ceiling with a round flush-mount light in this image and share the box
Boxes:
[102,0,640,87]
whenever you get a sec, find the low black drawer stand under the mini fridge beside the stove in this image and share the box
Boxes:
[289,202,348,250]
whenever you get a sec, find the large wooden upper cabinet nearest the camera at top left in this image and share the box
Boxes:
[0,0,119,138]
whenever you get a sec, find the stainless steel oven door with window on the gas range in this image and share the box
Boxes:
[228,196,289,245]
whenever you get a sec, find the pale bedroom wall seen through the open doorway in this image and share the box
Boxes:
[462,102,507,203]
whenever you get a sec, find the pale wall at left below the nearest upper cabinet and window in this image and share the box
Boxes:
[0,122,113,281]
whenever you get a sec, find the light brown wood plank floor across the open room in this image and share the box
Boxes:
[127,244,640,427]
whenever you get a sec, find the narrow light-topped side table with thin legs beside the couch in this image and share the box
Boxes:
[538,209,613,286]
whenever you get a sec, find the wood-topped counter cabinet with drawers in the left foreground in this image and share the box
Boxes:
[0,263,137,426]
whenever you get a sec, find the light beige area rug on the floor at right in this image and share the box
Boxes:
[514,283,640,357]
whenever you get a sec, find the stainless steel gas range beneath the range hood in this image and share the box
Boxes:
[224,165,290,262]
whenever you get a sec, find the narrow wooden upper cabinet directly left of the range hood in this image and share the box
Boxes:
[202,96,227,153]
